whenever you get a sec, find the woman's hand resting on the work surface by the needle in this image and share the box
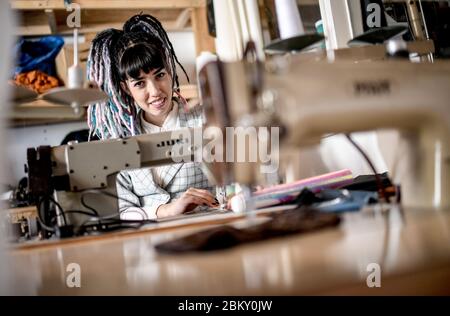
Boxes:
[156,188,219,218]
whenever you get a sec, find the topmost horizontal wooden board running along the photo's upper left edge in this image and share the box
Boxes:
[11,0,205,10]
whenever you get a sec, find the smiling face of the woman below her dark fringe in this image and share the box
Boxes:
[126,68,172,123]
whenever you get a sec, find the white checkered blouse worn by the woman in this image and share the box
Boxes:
[116,102,213,219]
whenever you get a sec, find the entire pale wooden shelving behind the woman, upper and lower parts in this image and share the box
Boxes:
[10,0,215,122]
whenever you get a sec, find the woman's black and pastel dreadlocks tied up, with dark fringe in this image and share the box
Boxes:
[87,14,189,139]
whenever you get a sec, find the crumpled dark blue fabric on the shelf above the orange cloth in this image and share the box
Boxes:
[14,36,64,77]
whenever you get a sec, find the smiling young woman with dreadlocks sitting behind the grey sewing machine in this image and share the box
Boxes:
[88,14,217,219]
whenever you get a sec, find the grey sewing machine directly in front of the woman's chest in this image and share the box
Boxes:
[27,128,201,235]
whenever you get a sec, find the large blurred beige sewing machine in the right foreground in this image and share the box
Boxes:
[200,57,450,208]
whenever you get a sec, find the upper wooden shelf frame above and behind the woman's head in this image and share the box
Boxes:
[10,0,215,55]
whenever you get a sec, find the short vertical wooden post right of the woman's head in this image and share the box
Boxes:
[191,6,216,56]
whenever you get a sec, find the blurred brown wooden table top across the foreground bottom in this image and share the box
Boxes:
[3,204,450,295]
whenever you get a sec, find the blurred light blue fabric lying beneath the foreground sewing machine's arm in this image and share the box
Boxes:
[312,190,378,213]
